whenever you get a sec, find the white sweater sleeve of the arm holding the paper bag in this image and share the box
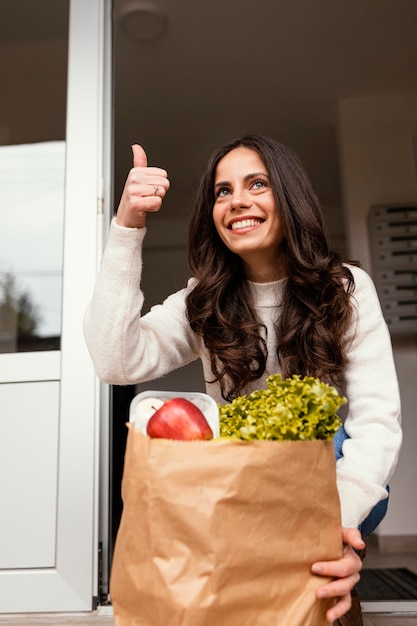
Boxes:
[337,267,402,527]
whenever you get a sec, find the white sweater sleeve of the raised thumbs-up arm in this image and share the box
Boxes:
[84,220,199,385]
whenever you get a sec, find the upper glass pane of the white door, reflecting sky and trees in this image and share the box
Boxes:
[0,0,69,352]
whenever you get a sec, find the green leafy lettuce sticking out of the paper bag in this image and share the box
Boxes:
[219,374,347,441]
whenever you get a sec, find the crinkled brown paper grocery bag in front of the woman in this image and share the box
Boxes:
[110,424,342,626]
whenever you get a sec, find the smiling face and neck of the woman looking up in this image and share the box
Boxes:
[213,146,285,282]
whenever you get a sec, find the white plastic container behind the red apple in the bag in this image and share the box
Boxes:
[129,390,220,438]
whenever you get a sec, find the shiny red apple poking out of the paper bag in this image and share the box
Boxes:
[146,398,213,440]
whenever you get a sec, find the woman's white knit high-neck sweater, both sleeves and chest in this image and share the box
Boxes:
[84,221,401,528]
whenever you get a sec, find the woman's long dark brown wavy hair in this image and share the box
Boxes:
[186,135,354,400]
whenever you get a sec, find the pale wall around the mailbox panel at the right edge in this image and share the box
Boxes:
[339,94,417,537]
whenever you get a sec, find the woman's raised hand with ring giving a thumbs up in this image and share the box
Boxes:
[116,144,170,228]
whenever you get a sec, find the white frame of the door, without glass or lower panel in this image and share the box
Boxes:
[0,0,111,613]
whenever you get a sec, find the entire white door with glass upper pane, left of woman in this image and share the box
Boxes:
[0,0,111,613]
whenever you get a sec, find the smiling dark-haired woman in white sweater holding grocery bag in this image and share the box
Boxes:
[85,135,401,623]
